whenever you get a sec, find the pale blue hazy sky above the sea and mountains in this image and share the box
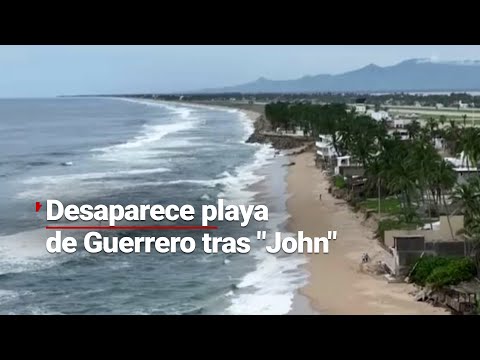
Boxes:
[0,45,480,98]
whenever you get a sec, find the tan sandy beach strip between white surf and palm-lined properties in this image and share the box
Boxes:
[287,152,448,315]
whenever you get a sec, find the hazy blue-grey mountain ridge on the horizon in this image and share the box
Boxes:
[201,59,480,93]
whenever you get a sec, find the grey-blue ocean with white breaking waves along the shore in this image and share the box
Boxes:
[0,98,307,314]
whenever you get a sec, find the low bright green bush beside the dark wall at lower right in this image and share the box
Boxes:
[411,256,476,289]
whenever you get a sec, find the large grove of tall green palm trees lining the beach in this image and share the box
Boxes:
[265,102,480,274]
